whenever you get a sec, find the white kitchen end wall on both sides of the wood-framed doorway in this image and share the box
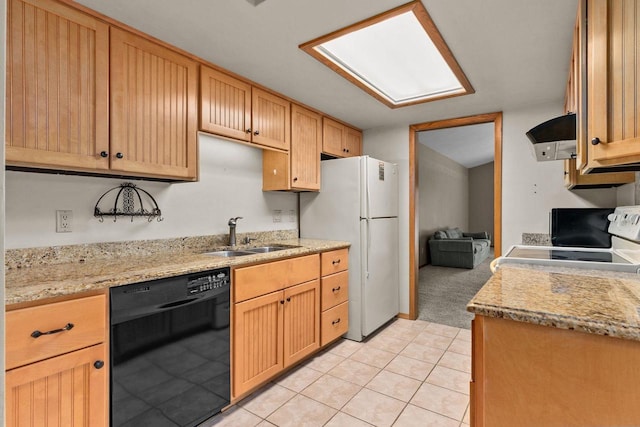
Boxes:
[363,104,617,313]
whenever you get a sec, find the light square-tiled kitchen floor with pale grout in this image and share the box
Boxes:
[201,319,471,427]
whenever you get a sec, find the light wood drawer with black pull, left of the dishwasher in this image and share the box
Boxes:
[6,295,107,369]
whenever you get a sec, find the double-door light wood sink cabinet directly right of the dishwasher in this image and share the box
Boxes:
[232,254,320,398]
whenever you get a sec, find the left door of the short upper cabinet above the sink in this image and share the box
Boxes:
[200,66,251,141]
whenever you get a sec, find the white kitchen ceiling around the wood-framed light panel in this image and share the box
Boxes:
[79,0,578,129]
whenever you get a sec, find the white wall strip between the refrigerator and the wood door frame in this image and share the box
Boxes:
[362,126,409,313]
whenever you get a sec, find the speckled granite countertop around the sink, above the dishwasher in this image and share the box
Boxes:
[5,239,350,305]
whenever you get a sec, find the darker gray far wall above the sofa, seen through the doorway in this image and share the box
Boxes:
[469,162,494,243]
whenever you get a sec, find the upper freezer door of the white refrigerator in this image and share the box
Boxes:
[360,156,398,218]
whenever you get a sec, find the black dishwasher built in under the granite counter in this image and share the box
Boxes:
[110,268,231,427]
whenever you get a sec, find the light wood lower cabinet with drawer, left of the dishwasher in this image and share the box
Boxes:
[5,295,109,427]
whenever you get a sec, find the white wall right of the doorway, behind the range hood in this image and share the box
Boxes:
[502,104,616,252]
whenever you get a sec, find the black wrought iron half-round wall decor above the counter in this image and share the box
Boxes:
[93,182,163,222]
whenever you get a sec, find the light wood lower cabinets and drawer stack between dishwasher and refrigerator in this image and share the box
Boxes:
[231,249,349,399]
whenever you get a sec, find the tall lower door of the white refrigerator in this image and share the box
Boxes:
[360,218,399,336]
